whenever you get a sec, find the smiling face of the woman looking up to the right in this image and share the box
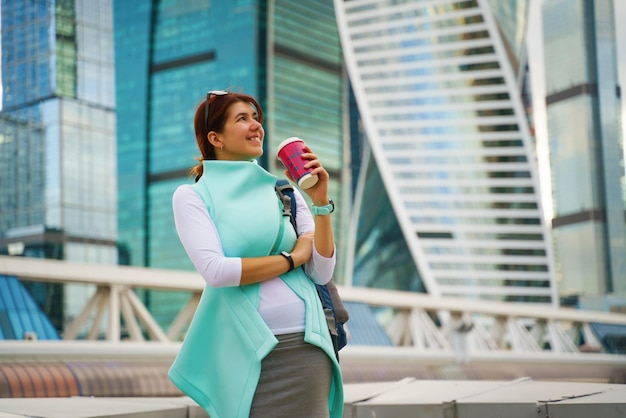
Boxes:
[216,102,265,161]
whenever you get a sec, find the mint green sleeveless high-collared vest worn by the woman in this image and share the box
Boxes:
[169,160,343,418]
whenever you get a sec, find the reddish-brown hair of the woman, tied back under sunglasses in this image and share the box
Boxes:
[191,92,263,181]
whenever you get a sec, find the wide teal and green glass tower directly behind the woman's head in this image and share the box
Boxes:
[114,0,347,322]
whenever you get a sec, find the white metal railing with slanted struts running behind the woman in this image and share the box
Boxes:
[0,256,626,363]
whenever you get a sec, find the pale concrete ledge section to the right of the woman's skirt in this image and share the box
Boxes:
[343,378,626,418]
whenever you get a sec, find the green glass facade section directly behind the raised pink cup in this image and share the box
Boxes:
[266,0,350,274]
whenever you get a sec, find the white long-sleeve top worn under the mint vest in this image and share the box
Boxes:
[172,184,336,335]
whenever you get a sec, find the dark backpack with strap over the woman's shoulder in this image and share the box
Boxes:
[276,180,348,359]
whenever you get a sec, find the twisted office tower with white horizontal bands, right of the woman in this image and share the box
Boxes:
[335,0,558,305]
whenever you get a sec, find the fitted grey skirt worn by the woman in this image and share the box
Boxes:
[250,332,332,418]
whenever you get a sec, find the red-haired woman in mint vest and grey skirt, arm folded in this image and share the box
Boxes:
[169,91,343,418]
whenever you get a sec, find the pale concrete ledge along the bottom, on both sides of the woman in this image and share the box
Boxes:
[0,378,626,418]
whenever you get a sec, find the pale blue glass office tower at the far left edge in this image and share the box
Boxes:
[0,0,117,320]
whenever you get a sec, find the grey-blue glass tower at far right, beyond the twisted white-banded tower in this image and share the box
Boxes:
[543,0,626,299]
